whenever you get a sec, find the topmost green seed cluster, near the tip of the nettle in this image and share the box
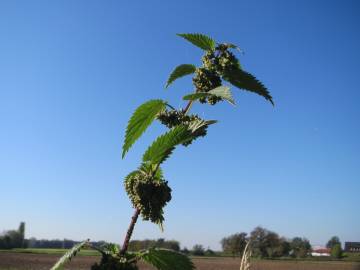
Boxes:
[193,44,240,105]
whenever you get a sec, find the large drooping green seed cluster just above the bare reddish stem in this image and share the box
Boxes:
[124,164,171,226]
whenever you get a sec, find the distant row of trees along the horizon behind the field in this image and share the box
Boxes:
[0,222,342,258]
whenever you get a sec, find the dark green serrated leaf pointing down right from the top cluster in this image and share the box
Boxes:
[223,69,274,105]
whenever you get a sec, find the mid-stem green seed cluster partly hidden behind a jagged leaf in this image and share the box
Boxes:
[157,110,207,146]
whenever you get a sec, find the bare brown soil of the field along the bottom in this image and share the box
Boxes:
[0,252,360,270]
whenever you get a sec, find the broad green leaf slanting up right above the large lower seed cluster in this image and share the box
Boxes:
[143,125,192,164]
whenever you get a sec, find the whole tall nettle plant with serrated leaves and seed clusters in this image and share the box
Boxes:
[52,34,273,270]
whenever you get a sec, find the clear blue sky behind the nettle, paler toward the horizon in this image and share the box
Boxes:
[0,0,360,249]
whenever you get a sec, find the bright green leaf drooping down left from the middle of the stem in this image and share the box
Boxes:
[122,99,166,158]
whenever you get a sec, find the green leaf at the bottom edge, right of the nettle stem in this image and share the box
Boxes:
[138,248,195,270]
